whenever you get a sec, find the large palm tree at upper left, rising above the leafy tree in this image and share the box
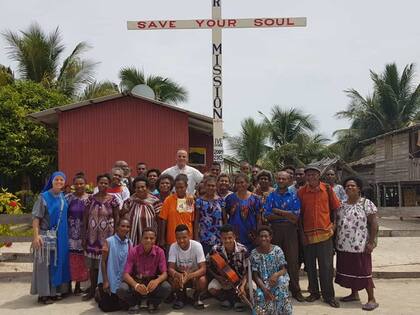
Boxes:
[3,23,95,97]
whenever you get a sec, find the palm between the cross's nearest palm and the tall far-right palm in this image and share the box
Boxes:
[259,105,315,147]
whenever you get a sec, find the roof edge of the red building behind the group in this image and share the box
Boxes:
[28,92,213,132]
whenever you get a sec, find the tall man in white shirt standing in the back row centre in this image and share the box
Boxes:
[162,149,203,195]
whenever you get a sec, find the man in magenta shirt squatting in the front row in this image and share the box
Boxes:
[117,228,171,314]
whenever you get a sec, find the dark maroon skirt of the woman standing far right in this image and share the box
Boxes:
[335,251,375,290]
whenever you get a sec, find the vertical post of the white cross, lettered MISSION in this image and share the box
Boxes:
[210,0,223,163]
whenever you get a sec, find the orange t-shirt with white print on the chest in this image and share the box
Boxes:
[159,194,194,244]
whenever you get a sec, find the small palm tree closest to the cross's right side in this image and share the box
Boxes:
[227,118,268,165]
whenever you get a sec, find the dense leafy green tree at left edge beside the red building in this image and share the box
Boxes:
[0,81,70,186]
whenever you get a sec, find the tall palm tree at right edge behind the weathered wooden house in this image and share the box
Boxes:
[335,63,420,160]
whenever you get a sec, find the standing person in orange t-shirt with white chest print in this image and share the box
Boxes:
[159,174,195,248]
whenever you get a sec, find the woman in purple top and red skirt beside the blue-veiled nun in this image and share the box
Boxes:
[66,173,89,295]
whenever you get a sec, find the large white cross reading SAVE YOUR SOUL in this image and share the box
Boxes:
[127,0,306,163]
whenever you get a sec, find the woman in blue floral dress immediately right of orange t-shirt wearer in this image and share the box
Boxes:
[194,176,224,255]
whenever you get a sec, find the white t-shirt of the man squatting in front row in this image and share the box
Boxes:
[168,240,206,272]
